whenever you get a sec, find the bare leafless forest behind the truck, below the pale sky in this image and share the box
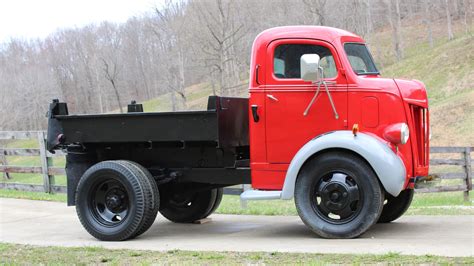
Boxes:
[0,0,474,130]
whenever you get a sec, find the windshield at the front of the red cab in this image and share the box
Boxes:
[344,43,380,75]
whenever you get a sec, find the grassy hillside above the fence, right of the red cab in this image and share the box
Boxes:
[382,35,474,145]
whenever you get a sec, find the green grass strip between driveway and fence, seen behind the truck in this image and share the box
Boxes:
[0,189,474,215]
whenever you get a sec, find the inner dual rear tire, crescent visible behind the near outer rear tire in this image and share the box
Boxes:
[120,161,160,237]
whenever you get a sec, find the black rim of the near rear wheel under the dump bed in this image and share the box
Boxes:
[89,177,130,226]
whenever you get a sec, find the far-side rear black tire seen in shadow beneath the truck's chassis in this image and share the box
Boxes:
[160,189,218,223]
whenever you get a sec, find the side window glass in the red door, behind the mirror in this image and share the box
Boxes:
[273,44,337,79]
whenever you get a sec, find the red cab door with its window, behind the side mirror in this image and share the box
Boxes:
[265,39,347,164]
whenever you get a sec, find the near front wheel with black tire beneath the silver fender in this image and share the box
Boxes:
[295,151,384,238]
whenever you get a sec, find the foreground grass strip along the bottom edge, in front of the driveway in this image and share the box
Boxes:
[0,243,474,265]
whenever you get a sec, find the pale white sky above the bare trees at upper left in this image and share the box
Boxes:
[0,0,164,43]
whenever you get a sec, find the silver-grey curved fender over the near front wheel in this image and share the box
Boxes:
[281,130,406,199]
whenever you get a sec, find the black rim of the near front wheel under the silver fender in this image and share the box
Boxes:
[310,171,363,224]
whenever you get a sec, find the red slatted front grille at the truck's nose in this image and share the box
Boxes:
[411,105,429,166]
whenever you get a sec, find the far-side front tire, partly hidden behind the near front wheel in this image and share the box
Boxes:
[377,189,415,223]
